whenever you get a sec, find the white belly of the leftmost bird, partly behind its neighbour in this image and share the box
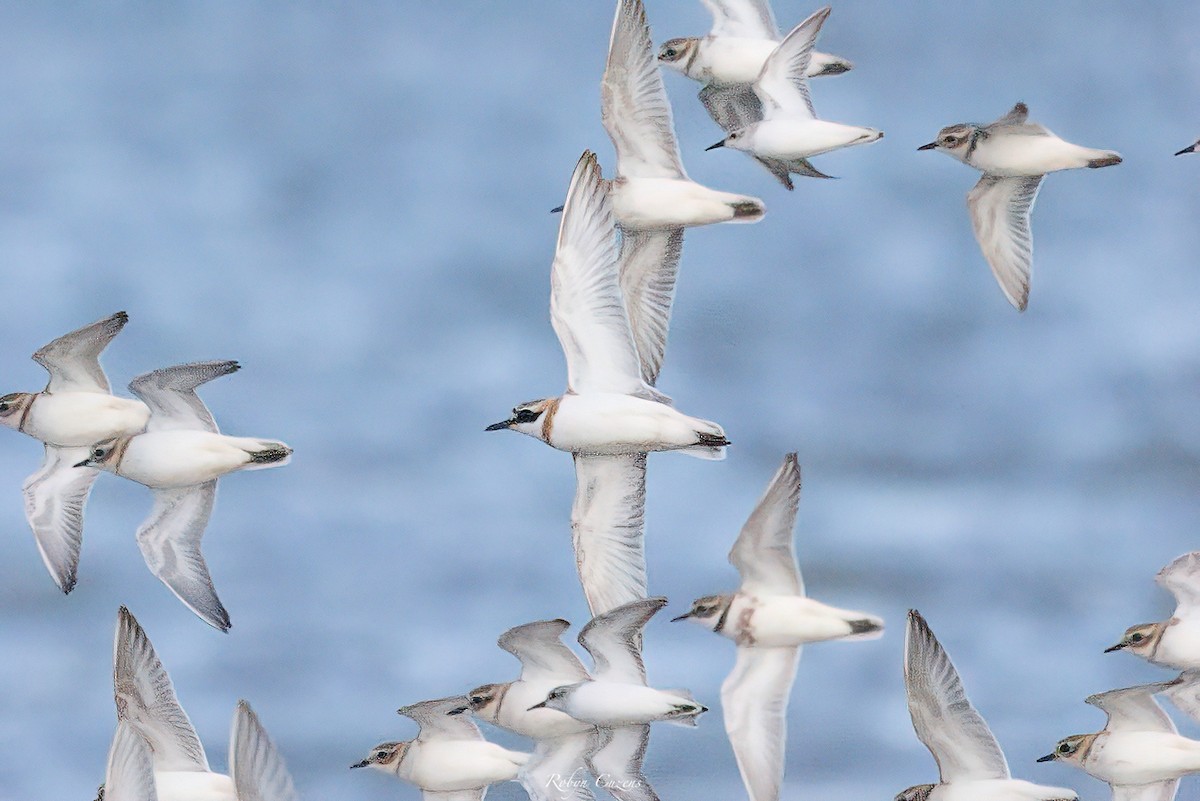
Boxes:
[25,392,150,447]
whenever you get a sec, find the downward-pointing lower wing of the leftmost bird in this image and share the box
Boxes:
[22,445,100,592]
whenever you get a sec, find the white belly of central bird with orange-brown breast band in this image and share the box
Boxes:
[550,393,724,454]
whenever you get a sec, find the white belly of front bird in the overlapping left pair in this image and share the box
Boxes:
[118,430,258,489]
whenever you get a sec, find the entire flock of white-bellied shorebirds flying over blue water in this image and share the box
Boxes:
[0,0,1200,801]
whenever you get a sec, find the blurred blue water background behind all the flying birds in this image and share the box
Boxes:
[0,0,1200,801]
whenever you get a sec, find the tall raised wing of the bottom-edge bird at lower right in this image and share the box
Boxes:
[904,609,1009,783]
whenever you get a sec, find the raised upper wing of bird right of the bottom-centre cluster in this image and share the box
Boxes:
[730,453,804,595]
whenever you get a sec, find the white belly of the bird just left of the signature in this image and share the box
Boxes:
[397,740,529,793]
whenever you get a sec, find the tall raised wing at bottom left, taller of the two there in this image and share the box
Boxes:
[113,607,209,772]
